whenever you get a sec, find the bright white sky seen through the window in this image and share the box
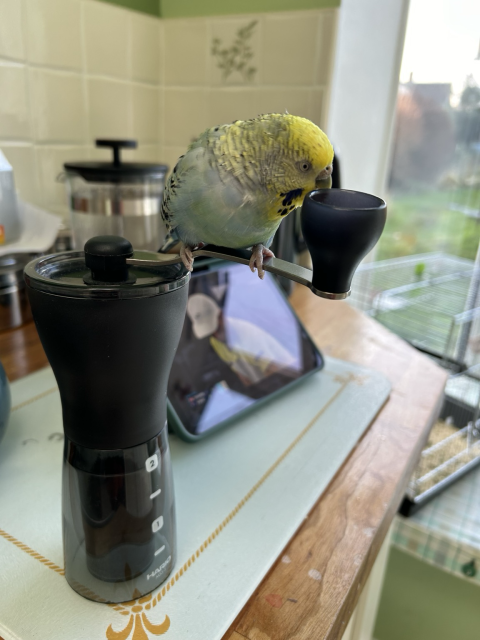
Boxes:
[400,0,480,100]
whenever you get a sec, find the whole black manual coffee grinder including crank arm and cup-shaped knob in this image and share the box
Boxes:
[25,189,386,602]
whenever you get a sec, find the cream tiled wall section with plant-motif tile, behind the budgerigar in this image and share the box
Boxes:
[161,9,337,188]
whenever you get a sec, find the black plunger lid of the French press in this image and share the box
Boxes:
[63,139,168,183]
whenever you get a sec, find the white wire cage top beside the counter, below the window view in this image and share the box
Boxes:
[350,253,480,371]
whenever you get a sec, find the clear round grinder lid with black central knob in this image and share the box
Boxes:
[25,236,190,299]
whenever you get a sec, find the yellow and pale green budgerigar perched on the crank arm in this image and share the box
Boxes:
[162,113,333,278]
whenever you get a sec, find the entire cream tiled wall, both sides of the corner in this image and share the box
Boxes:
[0,0,337,220]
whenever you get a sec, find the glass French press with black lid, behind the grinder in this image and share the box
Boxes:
[64,140,168,251]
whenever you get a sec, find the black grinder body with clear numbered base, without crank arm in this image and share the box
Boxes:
[25,238,189,602]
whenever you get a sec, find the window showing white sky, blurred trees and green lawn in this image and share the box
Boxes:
[375,0,480,260]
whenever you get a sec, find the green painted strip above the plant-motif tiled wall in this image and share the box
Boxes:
[160,0,340,18]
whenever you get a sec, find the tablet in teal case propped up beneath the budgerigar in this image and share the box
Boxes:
[168,262,323,441]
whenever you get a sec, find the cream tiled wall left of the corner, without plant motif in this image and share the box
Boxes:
[0,0,162,219]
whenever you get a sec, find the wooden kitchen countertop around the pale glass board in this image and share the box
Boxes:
[0,286,446,640]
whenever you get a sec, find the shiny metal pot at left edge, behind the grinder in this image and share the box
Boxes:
[0,254,32,331]
